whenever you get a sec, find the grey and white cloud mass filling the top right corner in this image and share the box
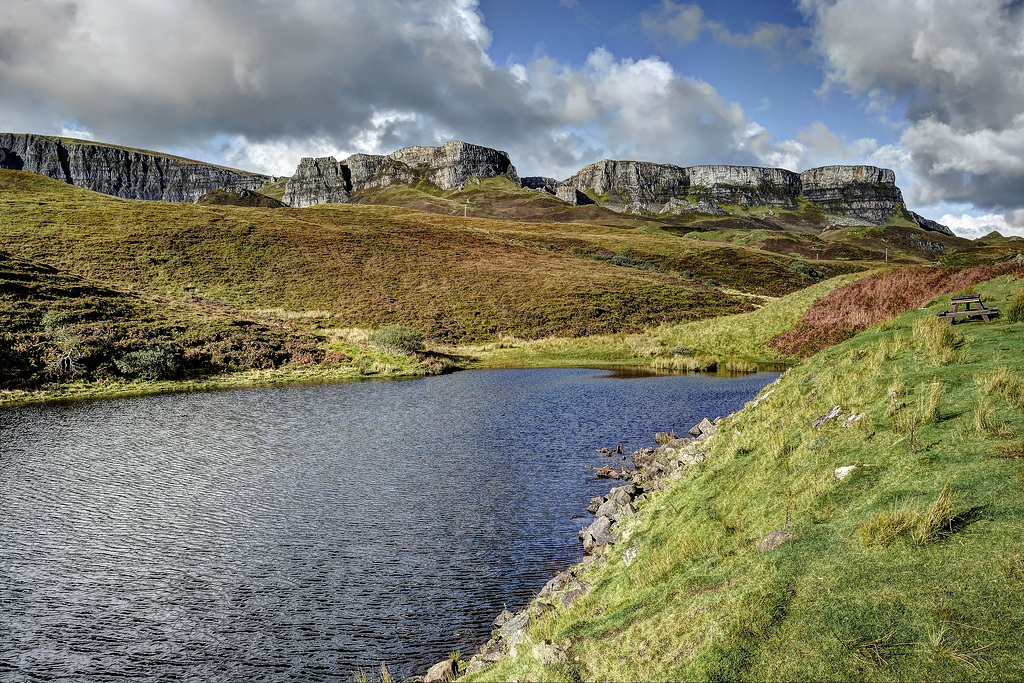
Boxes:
[800,0,1024,212]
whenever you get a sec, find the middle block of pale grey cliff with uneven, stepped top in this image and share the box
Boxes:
[285,141,519,207]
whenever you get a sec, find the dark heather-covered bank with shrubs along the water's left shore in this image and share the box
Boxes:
[0,251,438,405]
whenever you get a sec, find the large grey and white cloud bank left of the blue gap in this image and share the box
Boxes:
[0,0,884,187]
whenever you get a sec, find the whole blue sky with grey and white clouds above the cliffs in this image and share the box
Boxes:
[0,0,1024,238]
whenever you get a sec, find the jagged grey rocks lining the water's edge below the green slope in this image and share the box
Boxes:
[419,418,722,683]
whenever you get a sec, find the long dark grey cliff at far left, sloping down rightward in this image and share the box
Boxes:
[0,133,275,202]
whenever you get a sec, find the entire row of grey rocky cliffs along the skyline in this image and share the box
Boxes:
[0,133,953,237]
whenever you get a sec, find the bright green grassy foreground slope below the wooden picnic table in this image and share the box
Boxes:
[473,271,1024,681]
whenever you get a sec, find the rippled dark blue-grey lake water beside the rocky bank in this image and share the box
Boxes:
[0,370,775,682]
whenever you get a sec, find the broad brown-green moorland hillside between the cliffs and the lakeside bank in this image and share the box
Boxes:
[0,171,861,342]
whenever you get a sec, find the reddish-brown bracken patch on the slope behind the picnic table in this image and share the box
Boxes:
[768,263,1024,357]
